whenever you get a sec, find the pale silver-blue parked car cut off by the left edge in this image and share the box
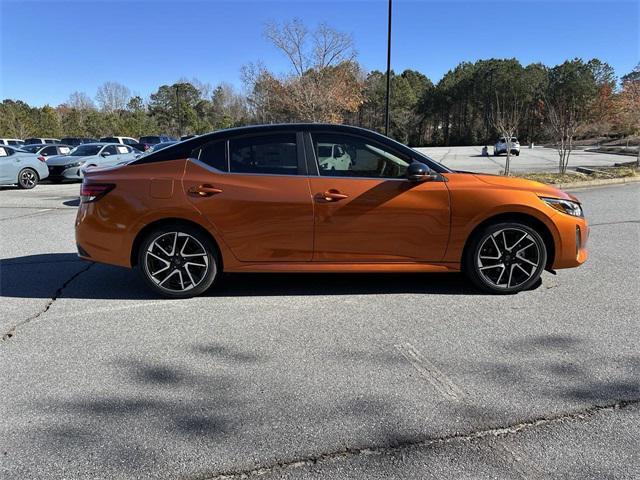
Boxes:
[0,145,49,189]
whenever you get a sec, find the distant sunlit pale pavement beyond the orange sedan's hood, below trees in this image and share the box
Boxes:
[416,145,634,173]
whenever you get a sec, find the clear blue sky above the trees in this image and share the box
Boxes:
[0,0,640,105]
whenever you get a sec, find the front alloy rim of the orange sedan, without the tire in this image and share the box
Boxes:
[476,227,543,290]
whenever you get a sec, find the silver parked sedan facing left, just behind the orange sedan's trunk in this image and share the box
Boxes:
[47,143,140,183]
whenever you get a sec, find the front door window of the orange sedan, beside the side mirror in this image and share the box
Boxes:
[313,133,411,178]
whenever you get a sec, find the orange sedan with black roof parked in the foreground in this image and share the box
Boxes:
[76,124,588,298]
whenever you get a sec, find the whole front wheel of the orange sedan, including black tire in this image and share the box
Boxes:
[463,222,547,295]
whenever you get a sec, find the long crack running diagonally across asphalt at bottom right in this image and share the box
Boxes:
[197,399,640,480]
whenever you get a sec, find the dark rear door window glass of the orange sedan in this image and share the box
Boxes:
[229,133,298,175]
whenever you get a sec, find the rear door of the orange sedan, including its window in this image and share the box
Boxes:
[183,130,313,262]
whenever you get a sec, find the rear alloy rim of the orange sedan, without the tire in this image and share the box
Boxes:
[144,231,211,293]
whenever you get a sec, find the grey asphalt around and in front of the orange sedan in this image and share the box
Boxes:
[0,180,640,479]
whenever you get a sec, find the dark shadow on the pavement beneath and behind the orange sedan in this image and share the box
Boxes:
[0,253,500,300]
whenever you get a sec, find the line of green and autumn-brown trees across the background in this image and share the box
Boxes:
[0,20,640,154]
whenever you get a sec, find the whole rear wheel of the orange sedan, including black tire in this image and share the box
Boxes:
[138,223,222,298]
